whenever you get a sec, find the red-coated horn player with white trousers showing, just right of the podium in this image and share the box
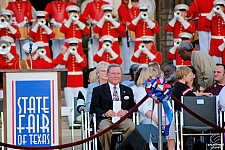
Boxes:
[60,38,87,125]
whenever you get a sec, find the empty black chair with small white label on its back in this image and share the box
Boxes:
[180,96,222,150]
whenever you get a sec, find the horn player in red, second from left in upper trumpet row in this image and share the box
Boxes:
[29,11,55,58]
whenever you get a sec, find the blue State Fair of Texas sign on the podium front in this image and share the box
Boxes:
[14,80,51,146]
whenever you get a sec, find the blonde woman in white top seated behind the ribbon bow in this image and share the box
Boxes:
[134,67,175,150]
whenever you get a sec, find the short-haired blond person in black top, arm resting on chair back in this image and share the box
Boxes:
[172,66,212,111]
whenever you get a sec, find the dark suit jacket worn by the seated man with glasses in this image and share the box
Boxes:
[90,83,135,124]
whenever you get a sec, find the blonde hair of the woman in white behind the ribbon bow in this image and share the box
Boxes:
[137,67,158,86]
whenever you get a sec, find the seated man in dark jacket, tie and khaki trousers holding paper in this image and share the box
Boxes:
[90,64,135,150]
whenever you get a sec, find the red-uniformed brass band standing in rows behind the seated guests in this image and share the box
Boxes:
[0,0,225,87]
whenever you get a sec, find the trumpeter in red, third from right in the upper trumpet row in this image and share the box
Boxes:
[128,4,160,52]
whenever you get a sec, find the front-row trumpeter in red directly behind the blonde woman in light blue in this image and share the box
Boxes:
[94,35,122,65]
